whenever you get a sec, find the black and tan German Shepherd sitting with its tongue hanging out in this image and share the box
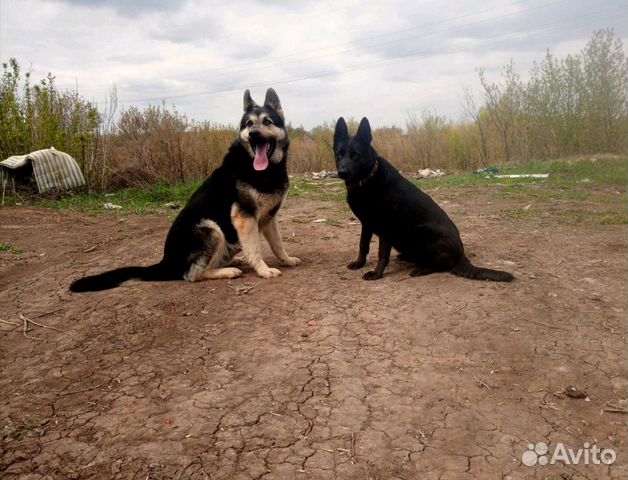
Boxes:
[70,88,301,292]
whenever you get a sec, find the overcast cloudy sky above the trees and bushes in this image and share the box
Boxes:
[0,0,628,129]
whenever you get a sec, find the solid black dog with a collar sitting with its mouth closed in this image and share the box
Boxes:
[334,117,514,282]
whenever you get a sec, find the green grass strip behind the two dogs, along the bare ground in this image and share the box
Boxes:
[6,156,628,219]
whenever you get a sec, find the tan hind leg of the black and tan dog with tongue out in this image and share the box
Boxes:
[183,220,242,282]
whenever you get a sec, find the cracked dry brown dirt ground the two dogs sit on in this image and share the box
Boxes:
[0,189,627,480]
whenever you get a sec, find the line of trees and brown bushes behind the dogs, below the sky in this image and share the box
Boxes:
[0,30,628,190]
